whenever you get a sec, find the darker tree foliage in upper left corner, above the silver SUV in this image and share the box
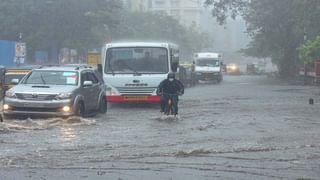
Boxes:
[0,0,121,60]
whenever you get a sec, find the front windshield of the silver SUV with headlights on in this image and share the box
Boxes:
[23,70,78,85]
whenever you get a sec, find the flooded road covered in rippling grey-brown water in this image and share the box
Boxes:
[0,76,320,180]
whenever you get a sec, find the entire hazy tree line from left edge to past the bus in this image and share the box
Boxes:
[0,0,211,62]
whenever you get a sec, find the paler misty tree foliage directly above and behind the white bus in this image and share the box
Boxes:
[106,11,212,59]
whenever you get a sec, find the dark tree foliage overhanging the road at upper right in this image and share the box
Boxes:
[206,0,320,76]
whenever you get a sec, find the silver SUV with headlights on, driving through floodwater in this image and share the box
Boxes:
[3,65,107,117]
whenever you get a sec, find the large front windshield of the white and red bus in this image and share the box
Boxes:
[105,47,169,74]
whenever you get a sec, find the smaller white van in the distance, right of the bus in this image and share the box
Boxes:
[194,52,223,82]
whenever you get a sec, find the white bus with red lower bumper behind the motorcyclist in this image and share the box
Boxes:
[101,42,179,103]
